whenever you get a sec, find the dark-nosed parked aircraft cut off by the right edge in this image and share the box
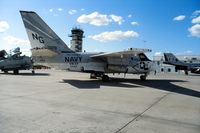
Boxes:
[164,53,200,75]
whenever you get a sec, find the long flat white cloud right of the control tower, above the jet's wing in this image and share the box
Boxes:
[89,31,139,42]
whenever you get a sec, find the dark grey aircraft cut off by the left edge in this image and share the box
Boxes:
[0,47,34,74]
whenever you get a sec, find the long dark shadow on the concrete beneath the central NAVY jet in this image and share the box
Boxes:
[60,78,200,98]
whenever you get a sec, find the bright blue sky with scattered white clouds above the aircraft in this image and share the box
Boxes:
[0,0,200,56]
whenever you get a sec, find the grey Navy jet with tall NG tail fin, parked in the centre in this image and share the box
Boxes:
[20,11,154,81]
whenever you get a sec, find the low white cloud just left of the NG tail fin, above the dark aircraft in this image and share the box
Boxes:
[3,36,30,45]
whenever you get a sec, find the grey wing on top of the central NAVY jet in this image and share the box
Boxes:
[91,48,152,58]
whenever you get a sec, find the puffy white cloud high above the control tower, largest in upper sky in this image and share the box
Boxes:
[77,12,111,26]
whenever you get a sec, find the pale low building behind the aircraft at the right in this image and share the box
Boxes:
[153,55,200,74]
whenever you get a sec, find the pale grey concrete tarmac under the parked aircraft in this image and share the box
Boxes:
[0,70,200,133]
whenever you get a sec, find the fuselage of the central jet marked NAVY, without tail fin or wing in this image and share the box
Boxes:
[33,52,153,74]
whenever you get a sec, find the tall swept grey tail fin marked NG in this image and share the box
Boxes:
[20,11,73,56]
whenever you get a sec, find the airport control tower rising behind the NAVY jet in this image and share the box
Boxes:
[69,27,84,52]
